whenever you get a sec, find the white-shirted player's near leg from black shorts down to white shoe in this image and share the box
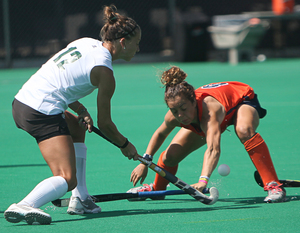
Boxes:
[4,100,72,224]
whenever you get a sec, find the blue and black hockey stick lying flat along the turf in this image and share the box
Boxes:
[52,188,209,207]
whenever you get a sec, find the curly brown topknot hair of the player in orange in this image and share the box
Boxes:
[160,66,195,104]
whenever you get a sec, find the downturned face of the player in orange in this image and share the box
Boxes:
[167,95,197,125]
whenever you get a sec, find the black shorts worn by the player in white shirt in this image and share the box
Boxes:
[12,99,70,143]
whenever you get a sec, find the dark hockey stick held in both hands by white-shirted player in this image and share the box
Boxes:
[92,126,219,205]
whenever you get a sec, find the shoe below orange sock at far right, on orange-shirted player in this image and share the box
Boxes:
[264,181,286,203]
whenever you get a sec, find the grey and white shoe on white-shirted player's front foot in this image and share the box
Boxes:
[67,196,101,214]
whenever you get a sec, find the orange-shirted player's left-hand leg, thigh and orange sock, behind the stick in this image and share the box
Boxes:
[153,128,206,190]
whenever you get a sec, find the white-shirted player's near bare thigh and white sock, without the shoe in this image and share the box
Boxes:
[23,135,76,203]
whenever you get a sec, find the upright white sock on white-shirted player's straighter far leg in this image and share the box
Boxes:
[72,142,89,200]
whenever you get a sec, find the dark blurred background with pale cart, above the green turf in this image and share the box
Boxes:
[0,0,300,68]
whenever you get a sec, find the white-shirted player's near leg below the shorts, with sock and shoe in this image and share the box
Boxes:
[5,135,76,224]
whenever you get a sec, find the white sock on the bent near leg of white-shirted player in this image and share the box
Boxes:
[18,176,68,208]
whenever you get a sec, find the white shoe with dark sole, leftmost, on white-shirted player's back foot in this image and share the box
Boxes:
[4,204,52,225]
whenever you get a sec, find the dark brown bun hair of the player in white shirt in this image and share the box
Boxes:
[100,5,141,41]
